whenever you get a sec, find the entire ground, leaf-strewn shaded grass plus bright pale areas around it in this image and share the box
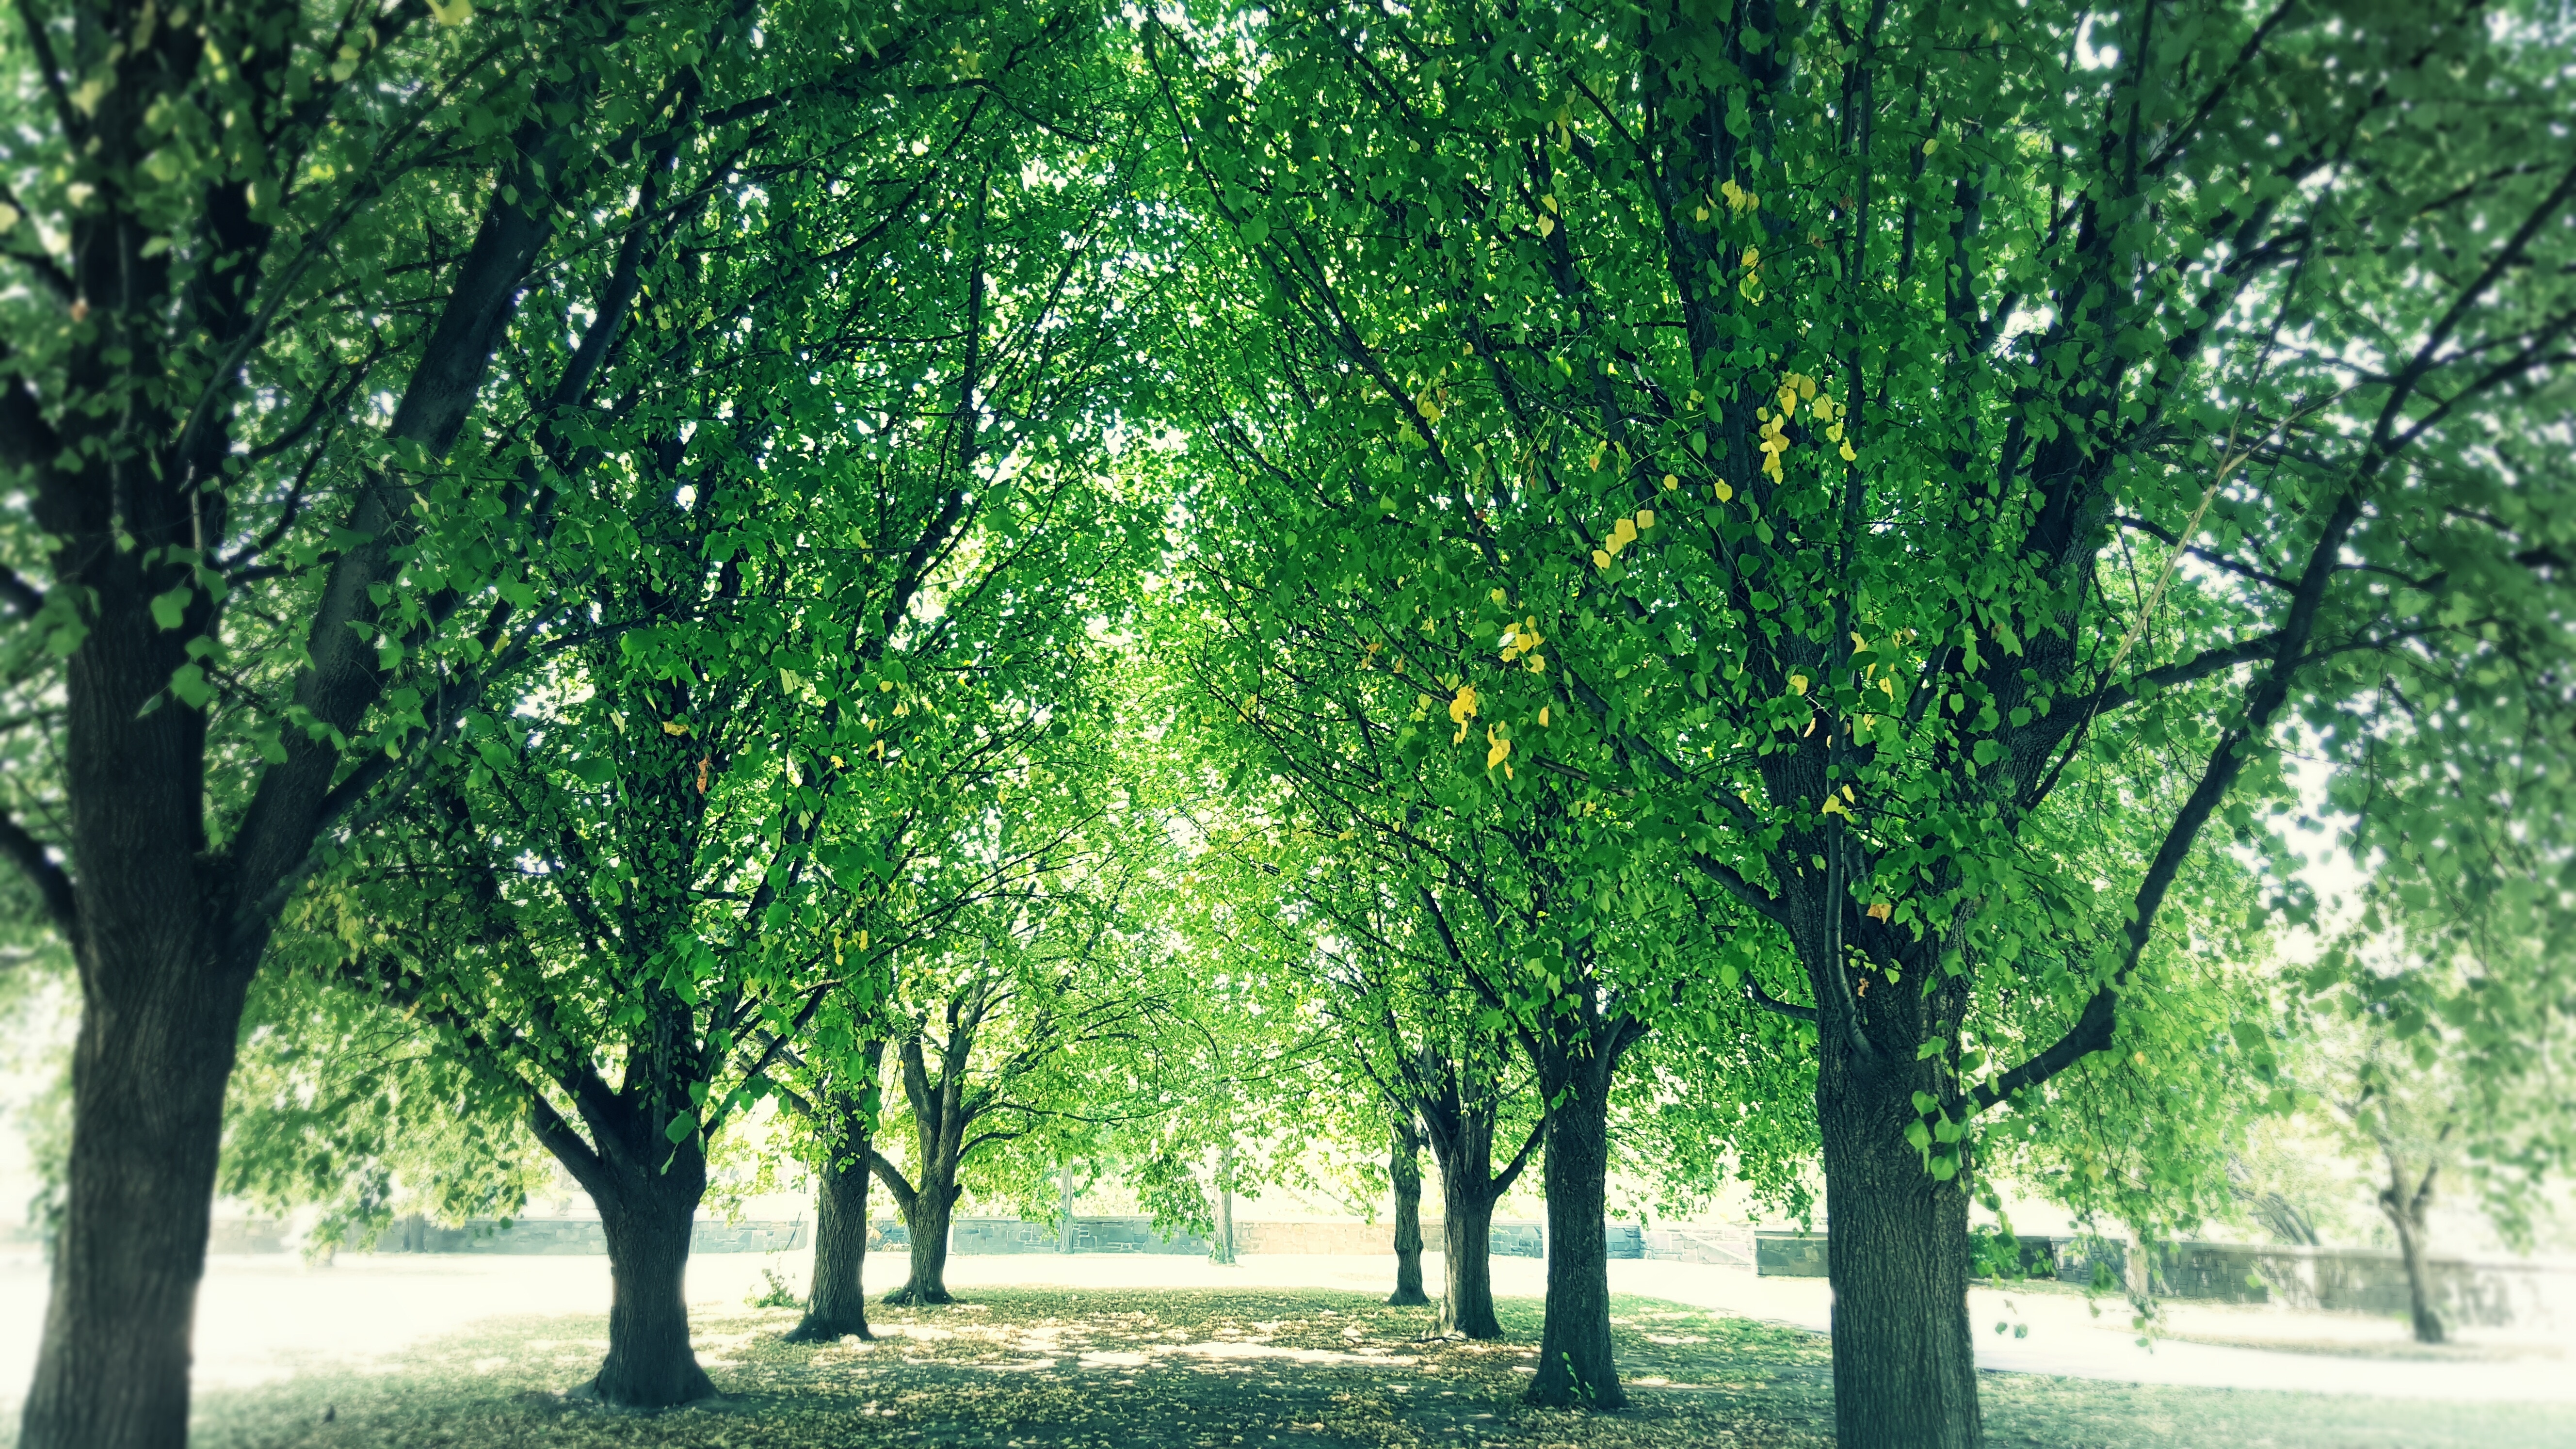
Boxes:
[0,1253,2576,1449]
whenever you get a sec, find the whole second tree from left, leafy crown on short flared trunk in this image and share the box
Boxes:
[296,2,1133,1405]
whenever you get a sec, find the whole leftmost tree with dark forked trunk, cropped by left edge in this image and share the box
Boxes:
[0,0,973,1449]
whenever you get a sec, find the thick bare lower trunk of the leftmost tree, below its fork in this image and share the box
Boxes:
[18,928,247,1449]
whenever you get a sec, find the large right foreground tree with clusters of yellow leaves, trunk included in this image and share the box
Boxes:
[1157,0,2576,1444]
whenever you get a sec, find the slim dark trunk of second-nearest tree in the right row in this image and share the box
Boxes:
[1514,1062,1617,1402]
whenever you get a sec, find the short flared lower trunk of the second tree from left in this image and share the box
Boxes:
[590,1173,716,1408]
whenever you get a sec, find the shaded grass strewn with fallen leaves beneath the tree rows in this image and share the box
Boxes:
[146,1289,2568,1449]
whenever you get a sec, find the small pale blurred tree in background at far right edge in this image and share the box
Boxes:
[2298,727,2576,1343]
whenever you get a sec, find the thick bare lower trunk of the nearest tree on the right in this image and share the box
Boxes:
[1816,1055,1983,1449]
